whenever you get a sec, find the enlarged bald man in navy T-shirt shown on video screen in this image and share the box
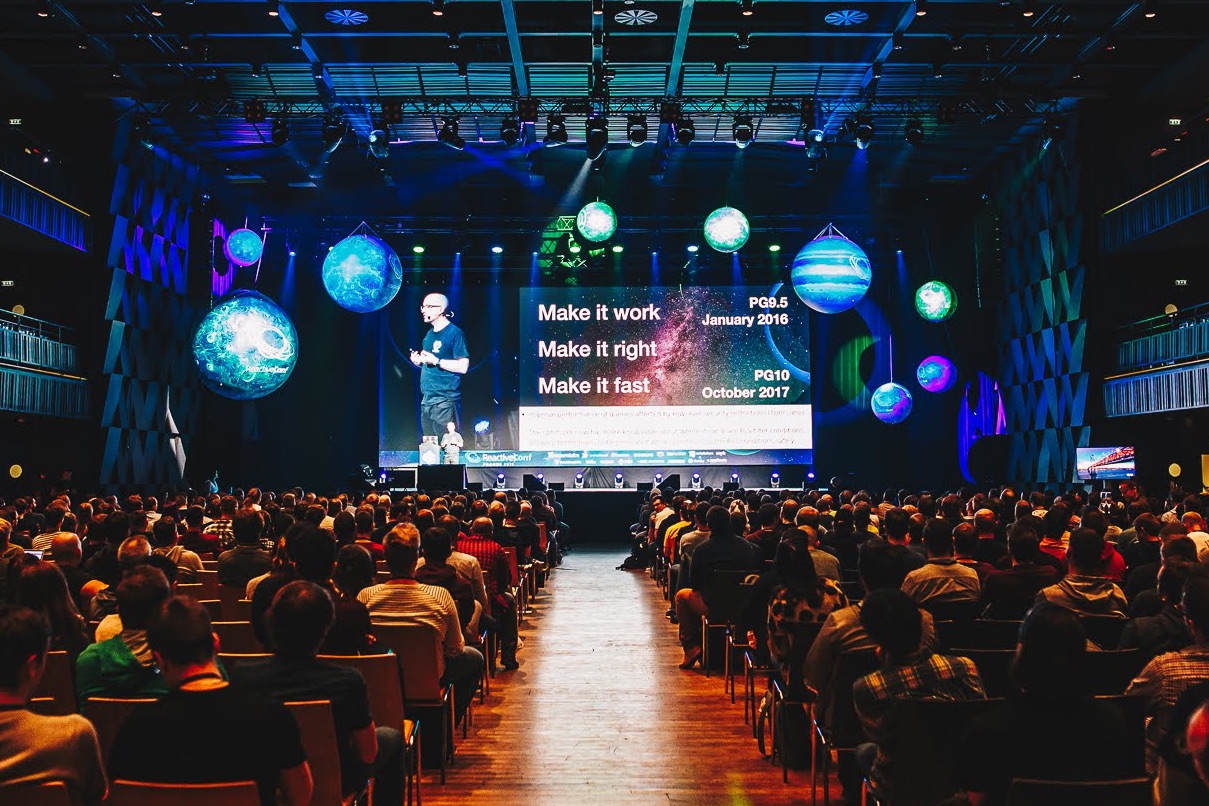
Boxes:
[411,294,470,439]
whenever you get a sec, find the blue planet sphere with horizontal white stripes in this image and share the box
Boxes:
[789,234,873,313]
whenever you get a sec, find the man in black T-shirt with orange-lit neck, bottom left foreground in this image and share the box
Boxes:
[109,596,313,806]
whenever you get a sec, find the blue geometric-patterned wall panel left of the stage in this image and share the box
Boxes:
[100,132,202,492]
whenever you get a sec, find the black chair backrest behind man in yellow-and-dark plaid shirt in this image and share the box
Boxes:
[885,698,1006,804]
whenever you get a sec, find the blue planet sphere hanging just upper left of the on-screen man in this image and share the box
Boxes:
[323,236,403,313]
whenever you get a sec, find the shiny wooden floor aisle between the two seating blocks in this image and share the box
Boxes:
[423,547,812,806]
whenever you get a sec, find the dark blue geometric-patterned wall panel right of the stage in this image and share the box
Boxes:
[997,124,1091,483]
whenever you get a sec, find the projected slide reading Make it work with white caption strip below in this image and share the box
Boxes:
[517,285,814,465]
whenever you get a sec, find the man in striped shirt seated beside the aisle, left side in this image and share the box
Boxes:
[357,522,484,720]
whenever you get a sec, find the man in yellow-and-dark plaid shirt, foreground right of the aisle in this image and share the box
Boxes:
[852,588,987,801]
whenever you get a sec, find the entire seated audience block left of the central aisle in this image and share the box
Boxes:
[0,489,568,806]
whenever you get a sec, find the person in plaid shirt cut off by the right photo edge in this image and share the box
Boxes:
[1126,568,1209,787]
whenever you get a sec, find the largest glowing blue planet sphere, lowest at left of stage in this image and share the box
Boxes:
[193,291,299,400]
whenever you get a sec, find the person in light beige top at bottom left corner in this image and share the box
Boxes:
[0,605,106,806]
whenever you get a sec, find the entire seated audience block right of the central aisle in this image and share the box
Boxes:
[621,482,1209,806]
